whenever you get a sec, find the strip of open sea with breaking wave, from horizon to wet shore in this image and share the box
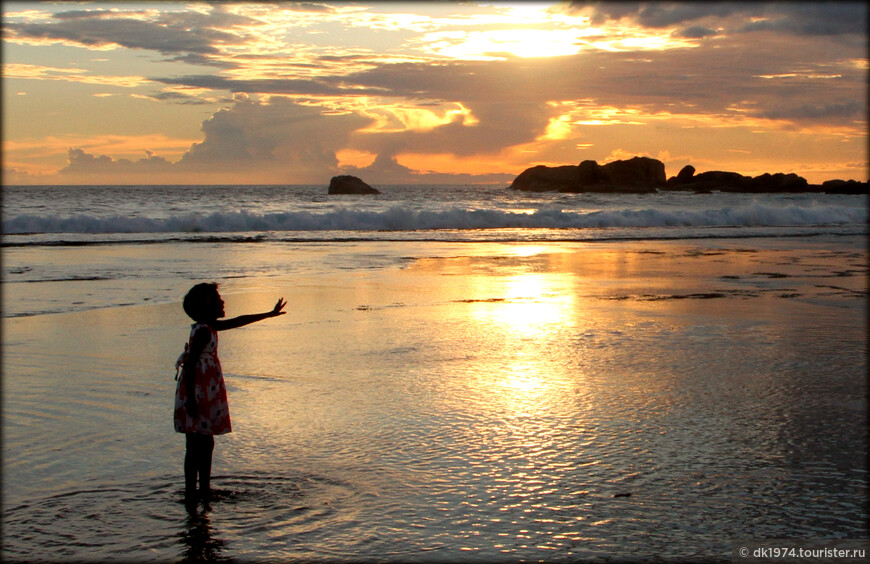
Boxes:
[3,185,867,244]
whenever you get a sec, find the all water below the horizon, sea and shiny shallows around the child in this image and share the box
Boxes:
[2,185,868,562]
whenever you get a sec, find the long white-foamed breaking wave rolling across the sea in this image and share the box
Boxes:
[3,203,867,234]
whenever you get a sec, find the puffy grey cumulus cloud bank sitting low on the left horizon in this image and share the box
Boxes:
[49,96,524,184]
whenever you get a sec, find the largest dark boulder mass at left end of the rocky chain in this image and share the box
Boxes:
[511,157,667,193]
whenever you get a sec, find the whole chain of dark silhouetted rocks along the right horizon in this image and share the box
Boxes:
[510,157,868,194]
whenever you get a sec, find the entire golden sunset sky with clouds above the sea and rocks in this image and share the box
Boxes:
[2,0,868,185]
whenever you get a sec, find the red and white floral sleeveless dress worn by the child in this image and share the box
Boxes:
[175,323,233,435]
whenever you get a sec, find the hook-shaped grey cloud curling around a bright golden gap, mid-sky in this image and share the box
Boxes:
[155,62,564,159]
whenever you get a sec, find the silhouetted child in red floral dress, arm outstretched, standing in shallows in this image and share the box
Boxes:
[175,283,286,506]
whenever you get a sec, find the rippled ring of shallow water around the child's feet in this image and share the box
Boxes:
[3,473,365,561]
